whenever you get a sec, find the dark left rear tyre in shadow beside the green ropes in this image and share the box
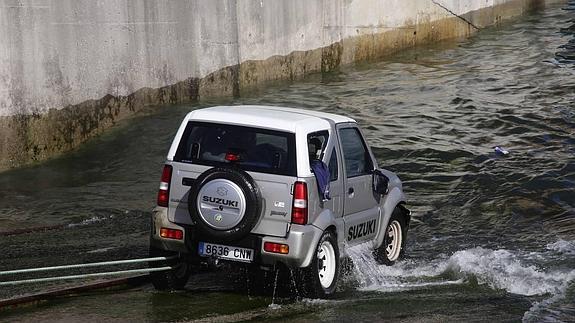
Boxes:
[149,246,192,290]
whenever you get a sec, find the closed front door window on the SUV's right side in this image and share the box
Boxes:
[339,128,373,178]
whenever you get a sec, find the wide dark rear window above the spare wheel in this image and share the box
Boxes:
[174,121,296,176]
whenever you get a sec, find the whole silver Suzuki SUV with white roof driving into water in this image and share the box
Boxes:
[150,106,410,297]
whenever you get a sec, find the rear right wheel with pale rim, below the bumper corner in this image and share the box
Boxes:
[302,231,340,298]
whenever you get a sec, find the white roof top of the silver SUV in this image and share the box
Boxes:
[188,105,355,133]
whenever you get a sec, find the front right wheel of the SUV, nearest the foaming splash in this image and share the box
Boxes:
[373,207,407,266]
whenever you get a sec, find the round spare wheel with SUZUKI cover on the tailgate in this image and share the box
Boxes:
[188,167,262,241]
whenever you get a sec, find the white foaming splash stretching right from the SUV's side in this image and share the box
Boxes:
[348,245,575,296]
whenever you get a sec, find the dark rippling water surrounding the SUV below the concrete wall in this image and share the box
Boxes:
[0,1,575,321]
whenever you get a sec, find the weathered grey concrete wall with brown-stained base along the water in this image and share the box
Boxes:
[0,0,545,170]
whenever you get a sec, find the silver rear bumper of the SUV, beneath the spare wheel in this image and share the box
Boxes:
[150,207,323,268]
